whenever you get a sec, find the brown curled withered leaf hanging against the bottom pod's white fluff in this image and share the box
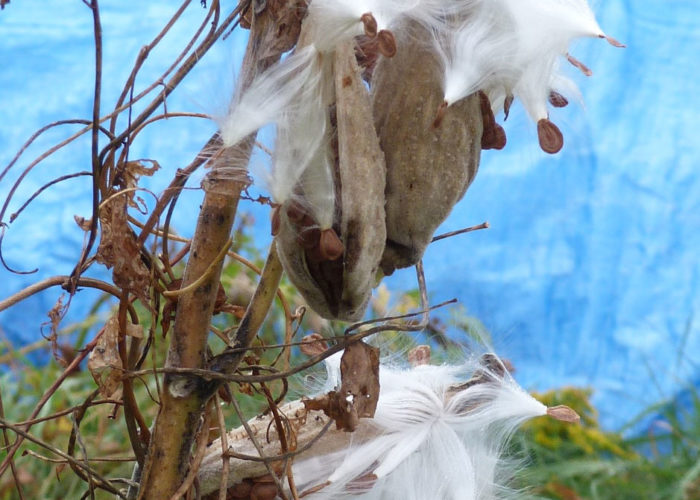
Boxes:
[304,341,379,432]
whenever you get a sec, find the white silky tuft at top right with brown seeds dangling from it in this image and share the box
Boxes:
[438,0,622,141]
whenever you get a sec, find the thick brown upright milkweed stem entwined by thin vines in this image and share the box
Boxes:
[134,0,302,499]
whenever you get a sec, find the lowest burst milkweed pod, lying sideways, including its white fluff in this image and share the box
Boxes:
[198,350,577,500]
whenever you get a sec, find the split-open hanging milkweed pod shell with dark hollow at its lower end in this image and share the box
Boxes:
[276,40,386,321]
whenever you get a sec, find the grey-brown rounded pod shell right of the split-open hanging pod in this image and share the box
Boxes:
[371,21,483,275]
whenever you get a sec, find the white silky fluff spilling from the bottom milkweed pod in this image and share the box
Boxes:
[294,356,547,500]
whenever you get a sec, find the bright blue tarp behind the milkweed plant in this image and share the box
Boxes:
[0,0,700,428]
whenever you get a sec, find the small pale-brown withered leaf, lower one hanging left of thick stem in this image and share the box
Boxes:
[88,316,124,398]
